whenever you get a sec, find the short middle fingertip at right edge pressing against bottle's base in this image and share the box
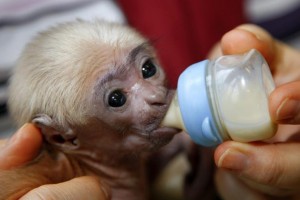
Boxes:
[269,81,300,124]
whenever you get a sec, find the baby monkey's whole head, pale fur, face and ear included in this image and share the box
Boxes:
[9,21,178,152]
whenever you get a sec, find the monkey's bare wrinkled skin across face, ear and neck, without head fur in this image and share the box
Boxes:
[0,22,183,200]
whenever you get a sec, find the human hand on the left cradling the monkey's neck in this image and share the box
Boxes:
[0,124,110,200]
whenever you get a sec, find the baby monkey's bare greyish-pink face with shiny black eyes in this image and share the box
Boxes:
[91,43,178,149]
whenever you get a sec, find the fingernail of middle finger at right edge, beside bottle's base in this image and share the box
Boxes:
[276,98,300,121]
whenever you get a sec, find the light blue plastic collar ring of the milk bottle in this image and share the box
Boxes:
[177,60,223,146]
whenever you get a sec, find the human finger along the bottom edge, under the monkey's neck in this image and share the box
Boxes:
[20,176,111,200]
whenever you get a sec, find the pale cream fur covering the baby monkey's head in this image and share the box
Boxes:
[9,20,149,124]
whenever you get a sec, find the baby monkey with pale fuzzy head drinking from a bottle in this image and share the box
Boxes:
[4,20,182,200]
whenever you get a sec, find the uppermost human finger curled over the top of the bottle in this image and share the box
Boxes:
[220,24,300,85]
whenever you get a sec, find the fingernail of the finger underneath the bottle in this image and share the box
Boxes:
[217,148,248,171]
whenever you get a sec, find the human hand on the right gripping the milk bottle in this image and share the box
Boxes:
[211,25,300,200]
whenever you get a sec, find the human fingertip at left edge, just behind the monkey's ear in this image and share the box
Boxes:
[0,124,42,170]
